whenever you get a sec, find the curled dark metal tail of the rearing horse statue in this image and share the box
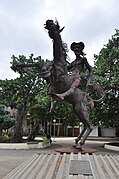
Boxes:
[89,83,106,103]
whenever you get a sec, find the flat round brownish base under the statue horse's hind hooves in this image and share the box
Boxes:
[55,147,97,155]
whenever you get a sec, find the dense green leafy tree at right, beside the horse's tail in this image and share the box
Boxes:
[93,29,119,134]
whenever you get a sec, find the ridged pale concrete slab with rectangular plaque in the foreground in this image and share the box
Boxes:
[4,153,119,179]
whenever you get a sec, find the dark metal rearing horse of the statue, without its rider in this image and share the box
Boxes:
[43,20,105,149]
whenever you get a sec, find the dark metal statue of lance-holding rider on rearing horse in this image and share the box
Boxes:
[11,20,105,150]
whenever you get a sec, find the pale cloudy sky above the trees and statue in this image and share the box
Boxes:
[0,0,119,80]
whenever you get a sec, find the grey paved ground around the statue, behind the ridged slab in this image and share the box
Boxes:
[0,138,119,179]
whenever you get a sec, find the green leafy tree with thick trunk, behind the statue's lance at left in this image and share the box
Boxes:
[11,54,47,142]
